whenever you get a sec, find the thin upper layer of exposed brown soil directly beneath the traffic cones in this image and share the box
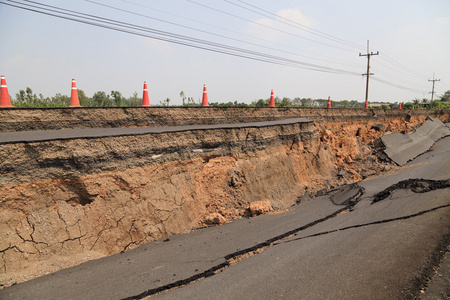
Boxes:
[0,107,449,132]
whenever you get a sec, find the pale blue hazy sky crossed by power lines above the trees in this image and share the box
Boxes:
[0,0,450,105]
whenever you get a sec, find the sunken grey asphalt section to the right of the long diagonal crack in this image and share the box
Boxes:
[152,138,450,299]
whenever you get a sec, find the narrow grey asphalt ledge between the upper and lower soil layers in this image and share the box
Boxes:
[0,118,312,144]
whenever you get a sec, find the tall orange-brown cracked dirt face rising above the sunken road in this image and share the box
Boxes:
[0,110,449,286]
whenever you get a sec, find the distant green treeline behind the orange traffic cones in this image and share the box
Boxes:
[7,87,450,109]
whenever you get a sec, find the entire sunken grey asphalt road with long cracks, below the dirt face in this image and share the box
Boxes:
[0,137,450,299]
